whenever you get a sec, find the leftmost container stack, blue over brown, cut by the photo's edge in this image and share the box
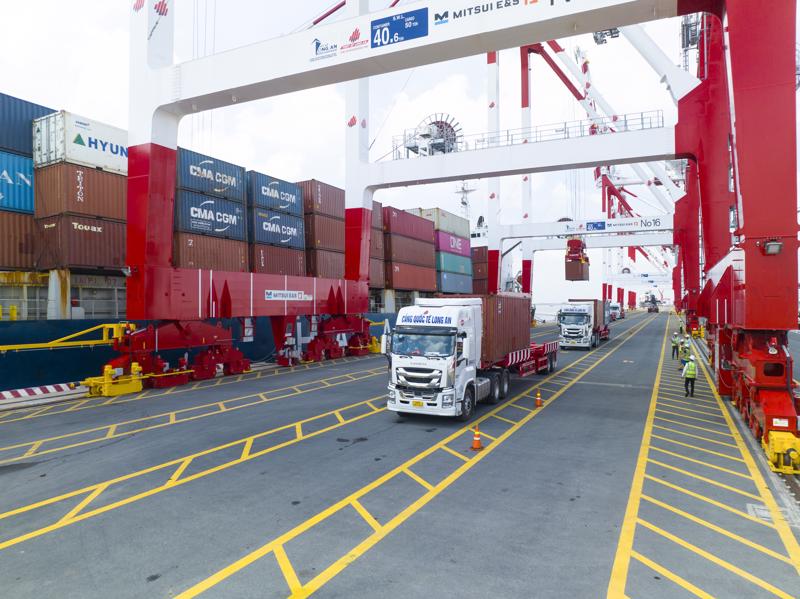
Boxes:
[0,94,53,270]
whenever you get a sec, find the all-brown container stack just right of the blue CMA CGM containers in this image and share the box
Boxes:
[298,179,344,279]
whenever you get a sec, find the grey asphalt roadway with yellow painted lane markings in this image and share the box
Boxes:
[0,313,800,599]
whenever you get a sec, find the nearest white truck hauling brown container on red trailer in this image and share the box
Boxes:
[381,294,558,420]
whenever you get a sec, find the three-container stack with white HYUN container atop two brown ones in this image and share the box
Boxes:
[33,110,128,271]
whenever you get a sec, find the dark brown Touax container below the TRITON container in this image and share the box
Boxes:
[35,214,126,270]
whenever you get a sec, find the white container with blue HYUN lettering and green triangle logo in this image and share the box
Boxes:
[33,110,128,175]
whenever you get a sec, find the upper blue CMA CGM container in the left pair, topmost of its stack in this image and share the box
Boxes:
[177,148,245,202]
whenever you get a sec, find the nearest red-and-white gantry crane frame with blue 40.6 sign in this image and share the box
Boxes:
[128,0,800,471]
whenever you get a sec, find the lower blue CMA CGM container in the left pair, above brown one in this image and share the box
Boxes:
[175,189,247,241]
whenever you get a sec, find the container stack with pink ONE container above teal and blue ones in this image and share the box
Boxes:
[409,208,472,293]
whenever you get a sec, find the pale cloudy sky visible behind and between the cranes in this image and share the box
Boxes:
[0,0,796,312]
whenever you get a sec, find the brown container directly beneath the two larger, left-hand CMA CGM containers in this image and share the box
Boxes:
[172,232,250,272]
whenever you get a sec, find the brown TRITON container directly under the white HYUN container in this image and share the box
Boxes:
[34,162,128,220]
